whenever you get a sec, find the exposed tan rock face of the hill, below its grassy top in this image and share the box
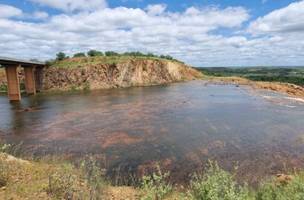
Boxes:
[44,59,200,90]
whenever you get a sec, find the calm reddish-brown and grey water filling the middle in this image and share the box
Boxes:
[0,81,304,183]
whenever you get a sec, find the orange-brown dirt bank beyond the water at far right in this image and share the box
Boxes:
[204,77,304,98]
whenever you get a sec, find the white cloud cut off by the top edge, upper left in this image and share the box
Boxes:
[30,0,107,12]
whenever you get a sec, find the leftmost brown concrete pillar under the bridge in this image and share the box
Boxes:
[5,66,21,101]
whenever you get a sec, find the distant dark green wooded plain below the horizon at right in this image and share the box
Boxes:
[198,67,304,86]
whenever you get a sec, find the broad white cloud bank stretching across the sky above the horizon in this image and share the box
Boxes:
[0,0,304,66]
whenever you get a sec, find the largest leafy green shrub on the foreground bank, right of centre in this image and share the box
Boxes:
[189,162,254,200]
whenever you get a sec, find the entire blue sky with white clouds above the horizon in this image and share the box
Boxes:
[0,0,304,66]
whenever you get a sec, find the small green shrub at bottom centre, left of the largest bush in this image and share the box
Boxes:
[141,166,173,200]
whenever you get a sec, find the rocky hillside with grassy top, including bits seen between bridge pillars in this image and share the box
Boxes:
[0,56,201,92]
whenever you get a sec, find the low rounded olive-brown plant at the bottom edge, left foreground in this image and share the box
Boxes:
[46,172,76,199]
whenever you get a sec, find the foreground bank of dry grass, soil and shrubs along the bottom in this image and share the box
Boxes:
[0,142,304,200]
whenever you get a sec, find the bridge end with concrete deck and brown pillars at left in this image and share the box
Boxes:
[0,57,45,101]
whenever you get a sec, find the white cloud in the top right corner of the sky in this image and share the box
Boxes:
[248,1,304,34]
